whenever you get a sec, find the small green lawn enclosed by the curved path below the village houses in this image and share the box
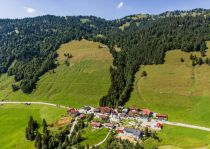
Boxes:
[81,127,108,146]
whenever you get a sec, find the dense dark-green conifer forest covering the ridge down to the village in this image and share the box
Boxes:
[0,9,210,106]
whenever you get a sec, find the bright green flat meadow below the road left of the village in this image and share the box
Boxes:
[0,104,66,149]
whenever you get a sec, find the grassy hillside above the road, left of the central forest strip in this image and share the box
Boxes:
[0,40,112,107]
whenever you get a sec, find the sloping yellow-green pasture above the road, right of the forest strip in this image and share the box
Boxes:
[127,42,210,127]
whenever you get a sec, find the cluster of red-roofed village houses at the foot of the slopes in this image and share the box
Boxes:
[67,106,168,140]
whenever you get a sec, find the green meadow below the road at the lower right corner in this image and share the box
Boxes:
[144,125,210,149]
